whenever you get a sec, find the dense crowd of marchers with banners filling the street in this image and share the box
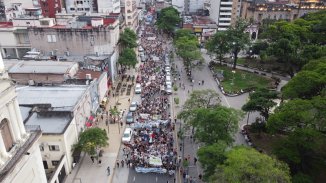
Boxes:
[123,23,178,174]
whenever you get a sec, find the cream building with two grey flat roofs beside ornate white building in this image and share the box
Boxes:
[17,85,94,183]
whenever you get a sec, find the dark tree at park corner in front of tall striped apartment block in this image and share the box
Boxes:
[206,32,230,64]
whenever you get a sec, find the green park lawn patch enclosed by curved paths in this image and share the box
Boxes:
[215,66,272,93]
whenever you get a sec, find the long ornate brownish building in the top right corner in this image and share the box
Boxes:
[241,0,326,23]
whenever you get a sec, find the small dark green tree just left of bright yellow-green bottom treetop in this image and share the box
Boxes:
[197,141,228,180]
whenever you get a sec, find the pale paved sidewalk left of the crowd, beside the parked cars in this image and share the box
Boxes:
[66,80,133,183]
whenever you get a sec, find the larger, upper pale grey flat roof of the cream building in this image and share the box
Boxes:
[16,85,88,111]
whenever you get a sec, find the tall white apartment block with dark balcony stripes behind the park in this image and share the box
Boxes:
[209,0,241,30]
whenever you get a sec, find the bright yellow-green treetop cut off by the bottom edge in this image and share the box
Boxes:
[210,147,291,183]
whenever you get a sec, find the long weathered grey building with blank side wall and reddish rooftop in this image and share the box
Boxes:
[28,17,119,56]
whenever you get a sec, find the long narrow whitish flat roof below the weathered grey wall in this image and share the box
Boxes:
[6,61,77,74]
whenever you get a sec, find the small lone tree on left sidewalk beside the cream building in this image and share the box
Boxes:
[73,128,109,156]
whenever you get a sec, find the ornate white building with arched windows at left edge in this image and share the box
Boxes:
[0,55,47,183]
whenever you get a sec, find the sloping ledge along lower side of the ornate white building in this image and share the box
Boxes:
[0,125,42,182]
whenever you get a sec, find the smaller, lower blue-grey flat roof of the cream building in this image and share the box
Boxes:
[25,112,71,134]
